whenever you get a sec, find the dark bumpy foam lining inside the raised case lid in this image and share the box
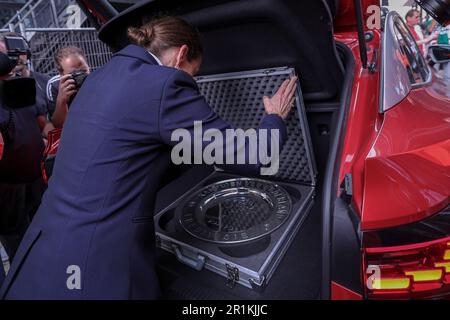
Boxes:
[197,68,316,185]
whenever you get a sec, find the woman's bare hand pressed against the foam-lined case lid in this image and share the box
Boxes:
[263,77,297,119]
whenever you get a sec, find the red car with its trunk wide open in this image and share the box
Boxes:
[4,0,450,299]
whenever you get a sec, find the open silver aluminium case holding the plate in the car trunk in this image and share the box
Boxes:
[155,67,316,290]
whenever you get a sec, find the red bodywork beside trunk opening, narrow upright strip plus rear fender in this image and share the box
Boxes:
[335,31,450,230]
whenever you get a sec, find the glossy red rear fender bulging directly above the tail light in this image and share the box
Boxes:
[361,78,450,230]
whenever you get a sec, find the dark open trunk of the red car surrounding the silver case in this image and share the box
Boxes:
[100,0,353,299]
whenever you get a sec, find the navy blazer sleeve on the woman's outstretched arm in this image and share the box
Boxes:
[159,70,287,174]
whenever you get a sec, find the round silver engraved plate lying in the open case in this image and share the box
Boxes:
[178,178,292,244]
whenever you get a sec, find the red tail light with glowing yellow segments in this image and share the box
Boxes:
[363,237,450,299]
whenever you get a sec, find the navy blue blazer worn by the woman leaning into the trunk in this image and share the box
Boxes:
[0,45,286,299]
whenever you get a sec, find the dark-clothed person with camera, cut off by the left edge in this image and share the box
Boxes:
[0,37,44,278]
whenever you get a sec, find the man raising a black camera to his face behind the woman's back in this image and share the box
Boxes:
[47,47,90,128]
